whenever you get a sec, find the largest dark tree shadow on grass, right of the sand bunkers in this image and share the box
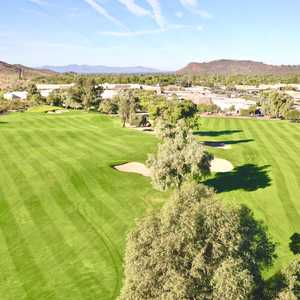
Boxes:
[203,164,271,193]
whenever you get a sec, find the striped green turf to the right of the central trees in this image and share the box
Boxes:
[199,118,300,276]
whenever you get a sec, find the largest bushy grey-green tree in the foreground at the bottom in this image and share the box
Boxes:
[120,183,274,300]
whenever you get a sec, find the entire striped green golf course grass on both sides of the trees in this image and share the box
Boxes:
[0,112,300,300]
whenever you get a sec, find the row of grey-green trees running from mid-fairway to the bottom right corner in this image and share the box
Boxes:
[119,120,300,300]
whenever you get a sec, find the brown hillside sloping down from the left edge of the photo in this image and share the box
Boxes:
[0,61,56,87]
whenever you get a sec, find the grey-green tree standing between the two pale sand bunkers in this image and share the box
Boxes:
[147,120,213,190]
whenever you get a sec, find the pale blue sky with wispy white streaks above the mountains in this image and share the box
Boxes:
[0,0,300,70]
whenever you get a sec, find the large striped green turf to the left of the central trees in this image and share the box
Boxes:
[0,113,165,300]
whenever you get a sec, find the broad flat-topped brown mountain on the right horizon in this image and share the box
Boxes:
[177,59,300,75]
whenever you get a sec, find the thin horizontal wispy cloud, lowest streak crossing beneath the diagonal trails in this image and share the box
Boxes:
[99,24,203,37]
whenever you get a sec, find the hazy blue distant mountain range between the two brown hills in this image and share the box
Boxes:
[42,65,161,74]
